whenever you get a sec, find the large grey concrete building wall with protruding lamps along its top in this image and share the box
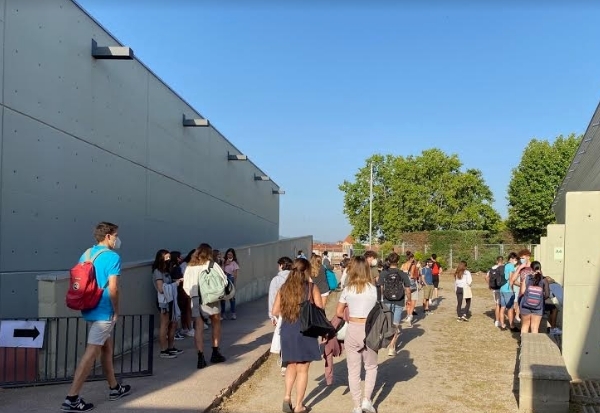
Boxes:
[0,0,280,317]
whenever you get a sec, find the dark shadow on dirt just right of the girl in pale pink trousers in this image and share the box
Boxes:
[373,350,418,408]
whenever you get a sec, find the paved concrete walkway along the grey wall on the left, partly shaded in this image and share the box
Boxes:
[0,296,273,413]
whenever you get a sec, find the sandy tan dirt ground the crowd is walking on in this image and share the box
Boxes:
[214,274,518,413]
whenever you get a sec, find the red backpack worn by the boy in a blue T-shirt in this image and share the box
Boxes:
[65,248,108,311]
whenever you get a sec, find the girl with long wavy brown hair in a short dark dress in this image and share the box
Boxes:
[272,258,323,413]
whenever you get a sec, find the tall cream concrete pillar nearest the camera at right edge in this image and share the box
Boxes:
[562,191,600,380]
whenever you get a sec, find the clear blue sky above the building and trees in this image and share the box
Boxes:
[80,0,600,241]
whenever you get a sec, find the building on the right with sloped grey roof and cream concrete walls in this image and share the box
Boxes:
[540,98,600,379]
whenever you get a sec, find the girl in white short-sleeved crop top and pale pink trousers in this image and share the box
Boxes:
[336,256,378,413]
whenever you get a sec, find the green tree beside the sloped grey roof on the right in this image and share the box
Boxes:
[506,134,582,243]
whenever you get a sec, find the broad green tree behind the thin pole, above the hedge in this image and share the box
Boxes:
[339,149,500,241]
